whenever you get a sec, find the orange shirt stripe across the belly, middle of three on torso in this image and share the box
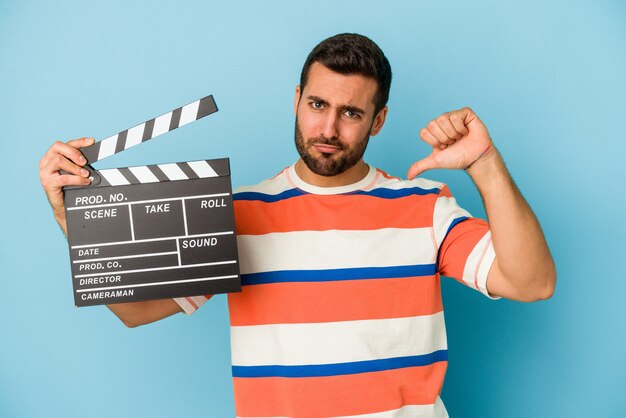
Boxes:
[228,275,443,326]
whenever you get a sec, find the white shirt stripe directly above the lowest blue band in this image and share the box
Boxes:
[230,312,447,366]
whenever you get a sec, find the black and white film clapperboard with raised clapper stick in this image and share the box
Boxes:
[64,96,241,306]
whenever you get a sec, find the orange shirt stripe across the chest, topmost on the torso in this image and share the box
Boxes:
[234,194,437,235]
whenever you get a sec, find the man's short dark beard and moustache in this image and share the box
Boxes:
[294,117,370,177]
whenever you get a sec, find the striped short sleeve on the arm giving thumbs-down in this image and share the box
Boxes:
[433,186,499,299]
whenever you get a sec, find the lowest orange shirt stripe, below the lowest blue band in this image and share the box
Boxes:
[233,361,447,417]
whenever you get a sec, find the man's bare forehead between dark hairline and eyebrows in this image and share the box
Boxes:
[302,62,378,111]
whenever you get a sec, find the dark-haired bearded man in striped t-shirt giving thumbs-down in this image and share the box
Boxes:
[40,34,556,417]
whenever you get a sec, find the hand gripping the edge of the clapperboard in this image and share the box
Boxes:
[39,138,94,233]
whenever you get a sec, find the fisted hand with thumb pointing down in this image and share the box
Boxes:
[407,107,491,180]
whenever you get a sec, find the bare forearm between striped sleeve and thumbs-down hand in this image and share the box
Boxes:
[467,147,556,301]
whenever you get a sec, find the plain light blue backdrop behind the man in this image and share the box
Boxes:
[0,0,626,418]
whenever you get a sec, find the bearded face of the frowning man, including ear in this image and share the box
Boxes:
[295,62,387,180]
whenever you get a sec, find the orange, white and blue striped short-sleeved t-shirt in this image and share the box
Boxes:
[176,166,495,418]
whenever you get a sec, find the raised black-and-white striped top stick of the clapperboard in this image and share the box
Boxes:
[81,95,217,167]
